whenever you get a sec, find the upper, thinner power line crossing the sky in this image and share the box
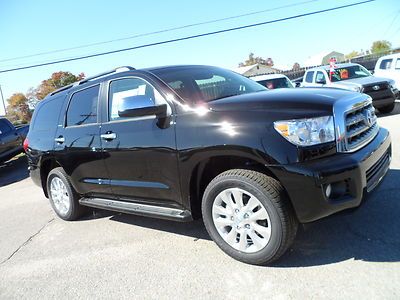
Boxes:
[0,0,320,62]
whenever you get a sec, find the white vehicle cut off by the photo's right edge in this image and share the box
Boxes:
[374,53,400,99]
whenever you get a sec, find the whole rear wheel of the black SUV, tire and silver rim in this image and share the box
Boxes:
[47,168,84,221]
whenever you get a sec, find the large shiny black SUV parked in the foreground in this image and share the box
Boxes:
[25,66,391,264]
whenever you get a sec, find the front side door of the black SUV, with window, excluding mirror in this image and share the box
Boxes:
[101,77,180,206]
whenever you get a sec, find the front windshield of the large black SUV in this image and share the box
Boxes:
[152,66,267,103]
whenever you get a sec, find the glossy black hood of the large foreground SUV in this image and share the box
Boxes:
[208,88,362,116]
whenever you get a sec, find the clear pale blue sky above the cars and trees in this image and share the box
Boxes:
[0,0,400,114]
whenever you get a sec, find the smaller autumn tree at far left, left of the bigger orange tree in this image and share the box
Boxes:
[7,93,32,123]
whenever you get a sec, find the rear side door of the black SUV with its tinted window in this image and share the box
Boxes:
[54,84,112,197]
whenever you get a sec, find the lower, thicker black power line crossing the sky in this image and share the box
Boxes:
[0,0,375,73]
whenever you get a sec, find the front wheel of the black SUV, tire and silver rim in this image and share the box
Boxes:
[202,169,298,265]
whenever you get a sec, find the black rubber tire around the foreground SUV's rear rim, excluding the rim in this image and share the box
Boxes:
[47,167,85,221]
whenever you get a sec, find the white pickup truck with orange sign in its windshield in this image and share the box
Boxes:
[302,63,396,113]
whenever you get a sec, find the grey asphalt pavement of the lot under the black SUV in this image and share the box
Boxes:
[0,103,400,299]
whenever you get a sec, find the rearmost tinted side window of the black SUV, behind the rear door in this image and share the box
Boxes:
[32,96,65,131]
